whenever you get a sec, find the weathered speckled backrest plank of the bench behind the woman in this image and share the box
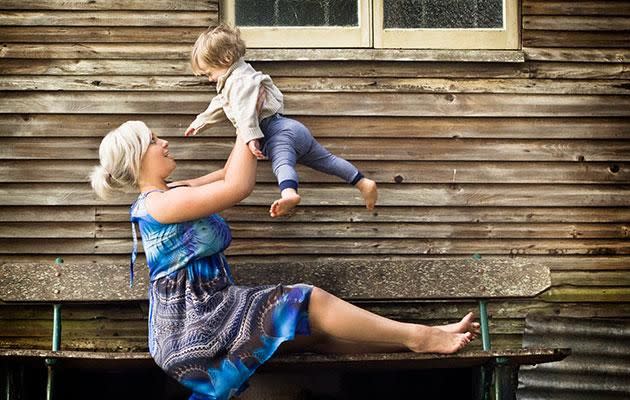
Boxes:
[0,259,551,302]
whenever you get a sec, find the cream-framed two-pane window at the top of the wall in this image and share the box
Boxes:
[222,0,519,49]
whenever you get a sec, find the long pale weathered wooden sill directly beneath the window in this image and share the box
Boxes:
[245,49,525,63]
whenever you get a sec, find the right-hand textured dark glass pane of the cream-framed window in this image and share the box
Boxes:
[383,0,503,29]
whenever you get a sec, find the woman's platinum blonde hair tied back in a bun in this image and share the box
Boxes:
[90,121,152,199]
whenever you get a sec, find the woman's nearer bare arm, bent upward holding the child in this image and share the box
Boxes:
[147,137,256,223]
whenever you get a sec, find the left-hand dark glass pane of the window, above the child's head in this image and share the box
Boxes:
[235,0,359,26]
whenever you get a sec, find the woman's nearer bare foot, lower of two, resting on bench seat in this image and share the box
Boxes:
[407,325,473,354]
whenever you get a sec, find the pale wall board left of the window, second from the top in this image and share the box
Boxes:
[0,10,219,27]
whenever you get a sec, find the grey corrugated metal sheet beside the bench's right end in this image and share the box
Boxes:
[516,315,630,400]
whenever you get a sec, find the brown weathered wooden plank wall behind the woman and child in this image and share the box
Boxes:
[0,0,630,349]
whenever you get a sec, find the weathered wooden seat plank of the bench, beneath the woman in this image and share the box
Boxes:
[0,348,571,371]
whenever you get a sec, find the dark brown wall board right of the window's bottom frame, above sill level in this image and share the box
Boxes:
[523,30,630,47]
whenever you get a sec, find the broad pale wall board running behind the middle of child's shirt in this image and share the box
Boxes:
[0,91,630,117]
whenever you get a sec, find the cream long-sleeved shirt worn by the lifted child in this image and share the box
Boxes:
[190,58,284,143]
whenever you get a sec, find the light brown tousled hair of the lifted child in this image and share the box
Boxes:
[190,24,246,75]
